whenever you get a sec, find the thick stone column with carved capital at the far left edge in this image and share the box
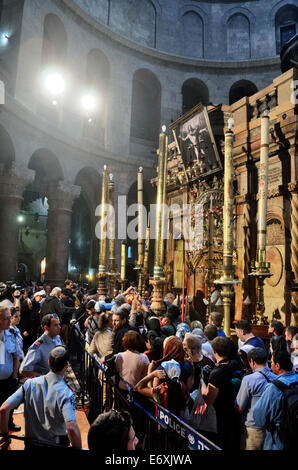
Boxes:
[0,162,35,282]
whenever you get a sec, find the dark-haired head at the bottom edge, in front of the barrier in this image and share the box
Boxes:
[88,410,138,454]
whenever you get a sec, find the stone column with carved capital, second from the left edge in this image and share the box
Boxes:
[45,181,81,286]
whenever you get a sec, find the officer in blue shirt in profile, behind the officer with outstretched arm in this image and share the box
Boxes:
[20,313,62,377]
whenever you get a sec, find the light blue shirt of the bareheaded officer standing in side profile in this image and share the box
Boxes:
[20,333,62,375]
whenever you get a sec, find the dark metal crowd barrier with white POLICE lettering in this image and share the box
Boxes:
[69,325,221,451]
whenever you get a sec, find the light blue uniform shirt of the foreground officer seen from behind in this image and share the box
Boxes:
[7,372,76,444]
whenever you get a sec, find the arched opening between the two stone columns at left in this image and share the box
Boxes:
[18,149,63,279]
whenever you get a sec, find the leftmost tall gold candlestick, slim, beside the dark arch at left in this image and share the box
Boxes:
[97,165,108,295]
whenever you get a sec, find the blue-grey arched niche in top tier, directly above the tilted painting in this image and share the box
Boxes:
[180,11,204,58]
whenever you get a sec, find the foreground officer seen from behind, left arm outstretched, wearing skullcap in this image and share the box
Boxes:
[0,346,82,450]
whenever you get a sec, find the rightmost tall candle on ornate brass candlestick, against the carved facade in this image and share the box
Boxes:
[249,110,272,325]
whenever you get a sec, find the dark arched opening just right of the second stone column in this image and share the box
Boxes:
[68,168,101,285]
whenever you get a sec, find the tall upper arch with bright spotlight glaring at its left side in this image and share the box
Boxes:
[84,49,110,144]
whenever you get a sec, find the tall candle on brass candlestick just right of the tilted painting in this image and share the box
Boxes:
[214,119,239,337]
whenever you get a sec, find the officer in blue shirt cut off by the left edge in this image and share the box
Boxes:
[0,307,21,432]
